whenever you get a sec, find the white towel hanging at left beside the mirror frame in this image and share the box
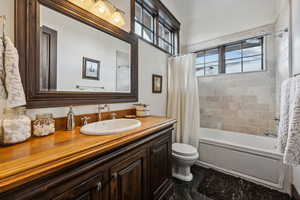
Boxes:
[2,37,26,108]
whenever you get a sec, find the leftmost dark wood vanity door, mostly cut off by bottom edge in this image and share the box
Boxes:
[53,176,106,200]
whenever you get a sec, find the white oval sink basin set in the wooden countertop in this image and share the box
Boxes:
[80,119,142,135]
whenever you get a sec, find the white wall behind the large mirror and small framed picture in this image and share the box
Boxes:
[0,0,176,118]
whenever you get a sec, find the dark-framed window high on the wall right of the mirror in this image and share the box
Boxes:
[135,0,180,55]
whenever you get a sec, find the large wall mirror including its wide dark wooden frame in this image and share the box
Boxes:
[15,0,138,108]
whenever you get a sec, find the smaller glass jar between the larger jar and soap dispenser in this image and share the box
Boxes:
[33,114,55,137]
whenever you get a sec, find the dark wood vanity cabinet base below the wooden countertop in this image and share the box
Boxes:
[0,127,173,200]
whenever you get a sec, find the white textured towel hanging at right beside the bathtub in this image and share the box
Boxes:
[283,77,300,166]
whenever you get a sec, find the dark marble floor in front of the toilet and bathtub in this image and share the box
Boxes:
[174,166,290,200]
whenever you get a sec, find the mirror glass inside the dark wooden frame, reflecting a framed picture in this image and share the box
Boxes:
[39,5,131,93]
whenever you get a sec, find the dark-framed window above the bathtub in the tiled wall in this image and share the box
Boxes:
[196,38,264,76]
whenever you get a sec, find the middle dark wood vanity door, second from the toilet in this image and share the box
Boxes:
[110,149,148,200]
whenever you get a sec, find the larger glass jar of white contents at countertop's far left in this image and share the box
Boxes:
[0,107,31,145]
